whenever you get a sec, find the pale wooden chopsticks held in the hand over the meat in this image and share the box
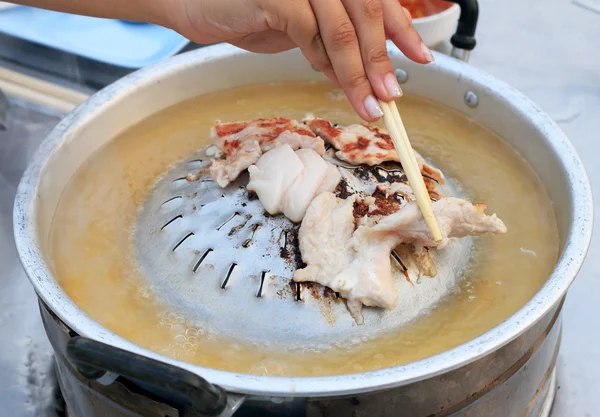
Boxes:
[380,101,443,244]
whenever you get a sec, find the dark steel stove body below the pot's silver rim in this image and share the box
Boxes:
[41,294,562,417]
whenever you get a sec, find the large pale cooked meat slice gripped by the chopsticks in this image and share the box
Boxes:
[294,193,506,324]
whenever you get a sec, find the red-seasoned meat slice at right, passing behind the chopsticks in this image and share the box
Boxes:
[304,118,444,184]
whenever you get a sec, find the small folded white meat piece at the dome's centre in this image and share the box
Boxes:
[247,144,341,223]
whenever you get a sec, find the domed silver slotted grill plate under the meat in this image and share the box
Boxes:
[133,151,472,348]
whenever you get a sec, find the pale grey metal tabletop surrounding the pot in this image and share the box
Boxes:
[0,0,600,417]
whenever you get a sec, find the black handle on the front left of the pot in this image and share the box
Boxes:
[66,336,244,417]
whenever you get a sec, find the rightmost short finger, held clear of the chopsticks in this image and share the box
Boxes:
[381,0,433,64]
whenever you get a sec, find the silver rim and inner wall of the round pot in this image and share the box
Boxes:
[14,39,593,397]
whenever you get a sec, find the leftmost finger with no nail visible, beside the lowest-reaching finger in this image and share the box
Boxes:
[271,0,340,87]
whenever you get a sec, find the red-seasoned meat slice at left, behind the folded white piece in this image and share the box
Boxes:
[210,117,325,187]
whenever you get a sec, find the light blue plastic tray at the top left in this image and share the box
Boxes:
[0,6,189,68]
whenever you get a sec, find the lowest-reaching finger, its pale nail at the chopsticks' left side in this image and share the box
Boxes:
[310,0,383,122]
